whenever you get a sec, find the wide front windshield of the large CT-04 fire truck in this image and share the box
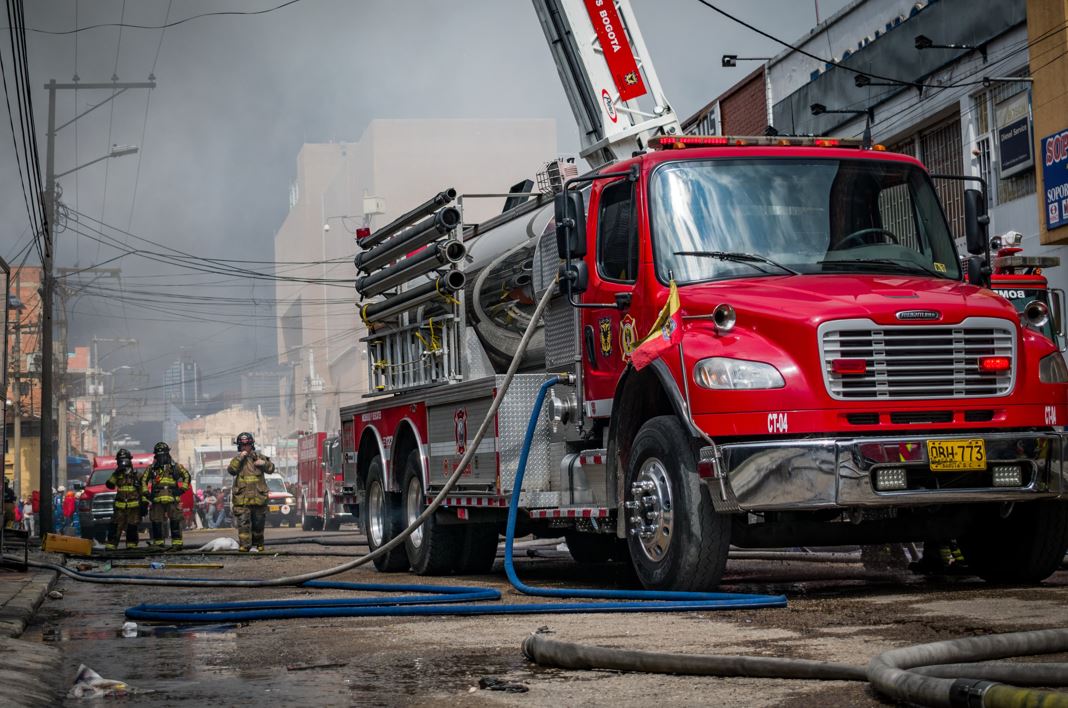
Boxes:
[649,158,960,285]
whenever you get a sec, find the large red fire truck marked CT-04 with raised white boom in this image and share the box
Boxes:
[341,0,1068,589]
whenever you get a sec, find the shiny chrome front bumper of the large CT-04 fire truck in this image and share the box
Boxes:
[698,431,1068,512]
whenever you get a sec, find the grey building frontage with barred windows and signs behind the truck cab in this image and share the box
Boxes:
[684,0,1068,288]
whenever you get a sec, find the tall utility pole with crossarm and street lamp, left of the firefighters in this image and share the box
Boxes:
[37,76,156,537]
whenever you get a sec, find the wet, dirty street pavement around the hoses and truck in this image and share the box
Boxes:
[23,530,1068,706]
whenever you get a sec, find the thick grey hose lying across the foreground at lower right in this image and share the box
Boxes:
[522,629,1068,708]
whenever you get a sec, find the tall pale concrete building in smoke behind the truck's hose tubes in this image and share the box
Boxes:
[274,120,556,435]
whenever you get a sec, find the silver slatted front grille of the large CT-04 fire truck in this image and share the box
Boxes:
[819,317,1016,400]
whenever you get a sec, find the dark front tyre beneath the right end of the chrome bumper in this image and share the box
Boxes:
[960,500,1068,583]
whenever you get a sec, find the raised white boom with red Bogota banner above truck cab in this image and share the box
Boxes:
[534,0,681,168]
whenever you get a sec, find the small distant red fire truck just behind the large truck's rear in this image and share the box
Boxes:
[297,432,354,531]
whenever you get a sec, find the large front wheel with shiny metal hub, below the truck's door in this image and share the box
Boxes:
[625,415,731,591]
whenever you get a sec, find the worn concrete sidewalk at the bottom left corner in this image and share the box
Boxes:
[0,553,66,706]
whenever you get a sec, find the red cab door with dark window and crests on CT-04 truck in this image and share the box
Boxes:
[581,179,639,410]
